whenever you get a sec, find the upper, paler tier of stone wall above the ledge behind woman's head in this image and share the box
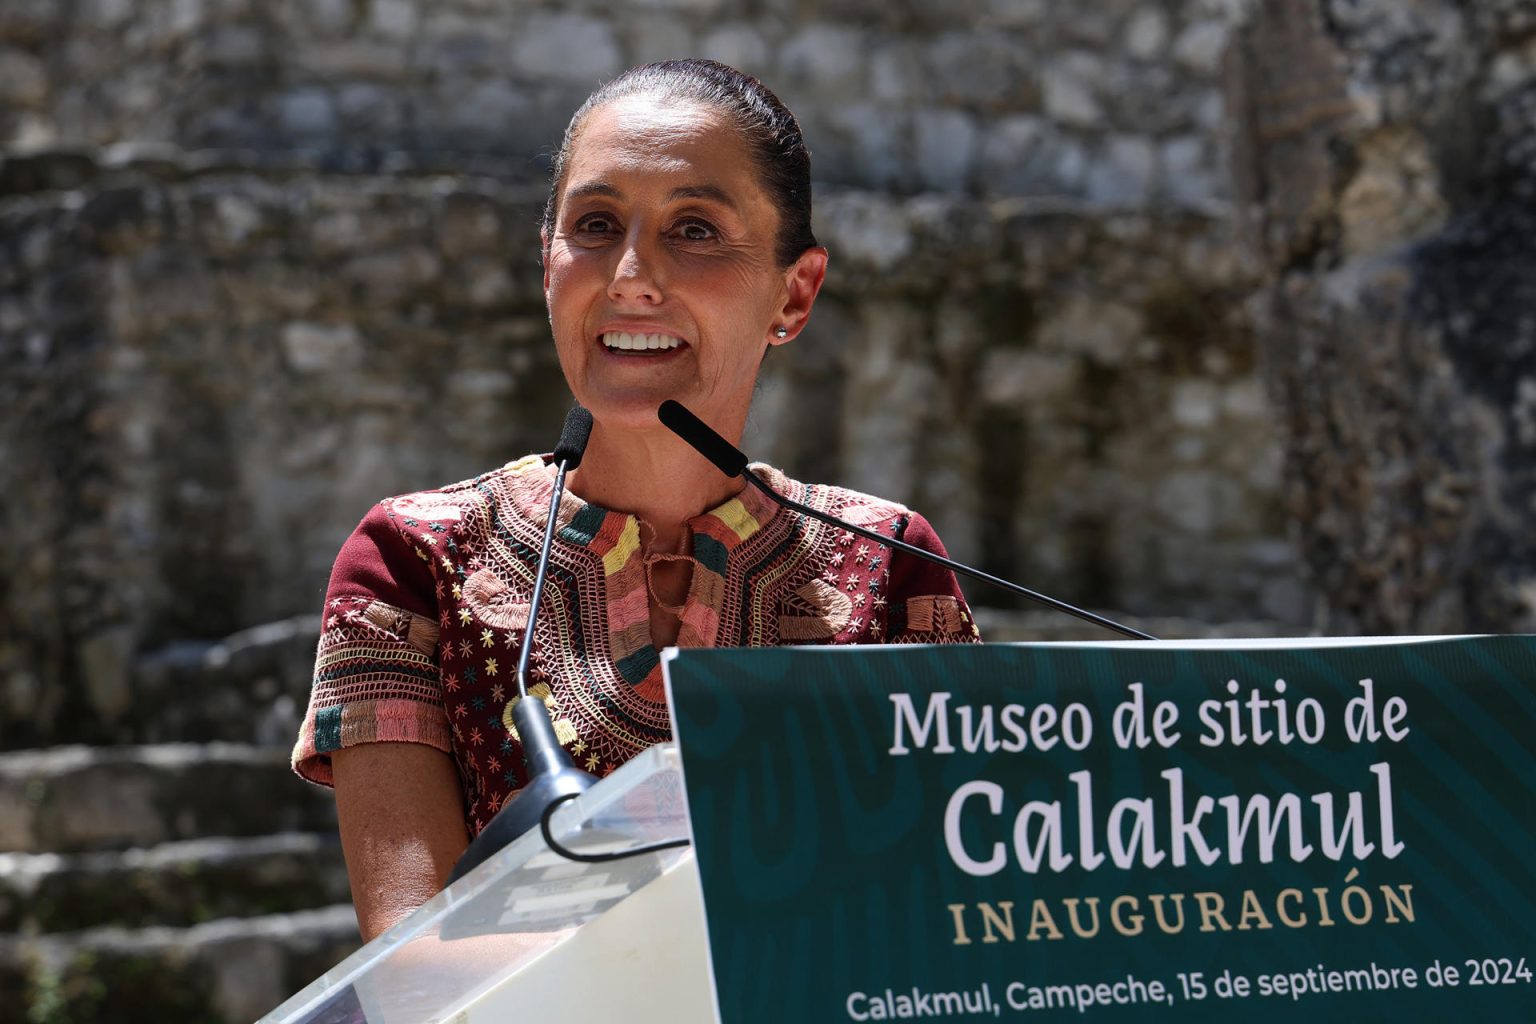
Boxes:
[0,0,1243,206]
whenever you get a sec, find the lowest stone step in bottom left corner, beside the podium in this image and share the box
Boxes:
[0,904,361,1024]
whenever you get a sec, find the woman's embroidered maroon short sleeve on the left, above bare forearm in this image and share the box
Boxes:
[293,504,453,786]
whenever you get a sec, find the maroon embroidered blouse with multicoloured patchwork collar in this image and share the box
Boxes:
[293,456,980,837]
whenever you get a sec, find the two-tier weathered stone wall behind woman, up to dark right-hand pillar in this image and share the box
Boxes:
[0,0,1310,745]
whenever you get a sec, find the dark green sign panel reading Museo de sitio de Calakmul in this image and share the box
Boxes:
[667,637,1536,1024]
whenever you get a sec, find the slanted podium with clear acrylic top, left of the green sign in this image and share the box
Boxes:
[258,743,717,1024]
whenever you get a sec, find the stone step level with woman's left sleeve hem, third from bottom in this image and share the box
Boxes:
[0,743,336,854]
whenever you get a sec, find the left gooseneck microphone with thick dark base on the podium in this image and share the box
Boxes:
[449,405,598,884]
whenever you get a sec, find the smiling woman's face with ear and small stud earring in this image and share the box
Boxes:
[544,97,826,436]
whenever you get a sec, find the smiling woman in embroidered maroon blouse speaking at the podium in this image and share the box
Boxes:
[293,61,977,940]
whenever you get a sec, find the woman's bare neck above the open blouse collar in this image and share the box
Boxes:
[565,424,743,551]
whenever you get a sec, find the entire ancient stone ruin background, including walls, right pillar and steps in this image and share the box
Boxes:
[0,0,1536,1022]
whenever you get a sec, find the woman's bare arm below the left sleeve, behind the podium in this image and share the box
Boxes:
[330,743,468,943]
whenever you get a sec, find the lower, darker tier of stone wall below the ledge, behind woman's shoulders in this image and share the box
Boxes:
[0,157,1277,743]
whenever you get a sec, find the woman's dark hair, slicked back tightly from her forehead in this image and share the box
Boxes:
[544,60,817,267]
